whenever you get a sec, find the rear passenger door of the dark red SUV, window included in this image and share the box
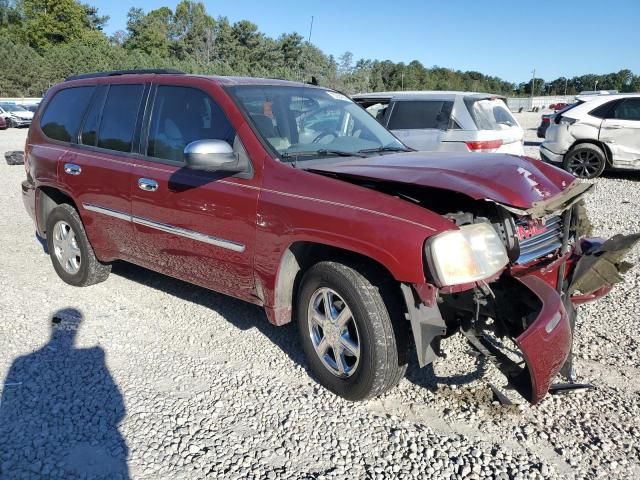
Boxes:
[58,83,149,260]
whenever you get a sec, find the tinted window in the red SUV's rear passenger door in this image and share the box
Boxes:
[95,85,144,152]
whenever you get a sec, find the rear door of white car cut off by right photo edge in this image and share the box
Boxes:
[600,98,640,168]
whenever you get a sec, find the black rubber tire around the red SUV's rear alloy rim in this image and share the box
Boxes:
[47,203,111,287]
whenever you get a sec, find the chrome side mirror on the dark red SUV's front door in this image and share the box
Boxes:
[184,139,244,172]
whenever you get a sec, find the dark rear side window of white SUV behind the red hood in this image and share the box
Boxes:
[388,100,453,130]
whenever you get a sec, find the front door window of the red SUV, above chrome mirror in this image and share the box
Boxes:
[147,85,236,161]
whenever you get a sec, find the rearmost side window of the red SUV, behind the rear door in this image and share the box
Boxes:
[40,86,95,142]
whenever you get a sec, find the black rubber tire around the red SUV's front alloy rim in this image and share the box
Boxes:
[297,262,408,401]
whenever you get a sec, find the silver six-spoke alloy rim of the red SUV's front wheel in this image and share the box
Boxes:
[308,287,360,378]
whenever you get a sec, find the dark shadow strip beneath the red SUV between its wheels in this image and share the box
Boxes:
[112,262,308,371]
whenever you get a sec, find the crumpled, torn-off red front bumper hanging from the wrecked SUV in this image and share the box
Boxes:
[402,234,640,404]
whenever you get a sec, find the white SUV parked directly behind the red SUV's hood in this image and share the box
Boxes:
[352,91,524,155]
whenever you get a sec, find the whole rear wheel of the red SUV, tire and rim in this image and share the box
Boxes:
[47,203,111,287]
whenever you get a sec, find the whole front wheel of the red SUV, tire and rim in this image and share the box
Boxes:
[297,262,406,400]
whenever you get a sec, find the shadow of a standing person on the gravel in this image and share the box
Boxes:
[0,308,129,479]
